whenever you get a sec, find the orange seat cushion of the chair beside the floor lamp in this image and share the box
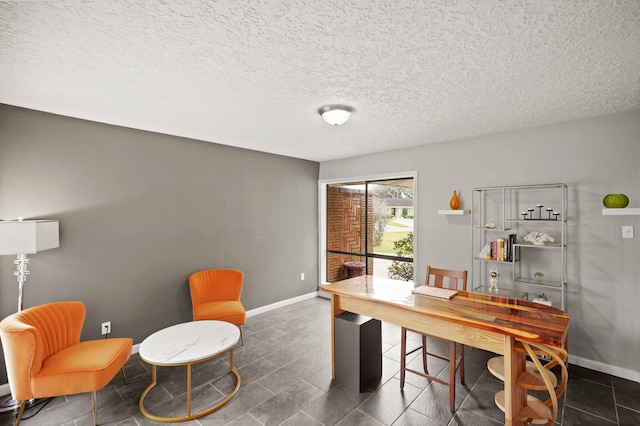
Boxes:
[31,338,133,398]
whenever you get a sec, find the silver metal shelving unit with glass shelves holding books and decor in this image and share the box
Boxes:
[471,183,568,310]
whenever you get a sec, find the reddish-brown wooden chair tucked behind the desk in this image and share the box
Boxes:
[400,266,467,411]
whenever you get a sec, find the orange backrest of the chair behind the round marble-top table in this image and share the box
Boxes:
[189,269,244,306]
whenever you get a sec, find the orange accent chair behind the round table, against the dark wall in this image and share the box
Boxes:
[189,269,247,346]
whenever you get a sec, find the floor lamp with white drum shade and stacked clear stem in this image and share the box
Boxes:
[0,219,59,413]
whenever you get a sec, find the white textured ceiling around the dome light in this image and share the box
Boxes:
[0,0,640,161]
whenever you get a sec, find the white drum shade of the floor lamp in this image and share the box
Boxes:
[0,220,60,255]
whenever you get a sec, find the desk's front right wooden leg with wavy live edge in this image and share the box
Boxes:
[504,336,527,426]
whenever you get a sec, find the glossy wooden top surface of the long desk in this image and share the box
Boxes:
[320,275,569,346]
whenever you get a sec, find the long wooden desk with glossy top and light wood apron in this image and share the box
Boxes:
[320,275,569,425]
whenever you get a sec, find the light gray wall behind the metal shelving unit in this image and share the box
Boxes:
[320,110,640,381]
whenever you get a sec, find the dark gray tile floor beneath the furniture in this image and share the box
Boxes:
[0,298,640,426]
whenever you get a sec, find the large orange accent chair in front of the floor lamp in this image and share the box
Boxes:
[0,301,133,426]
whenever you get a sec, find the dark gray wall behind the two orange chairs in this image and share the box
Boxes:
[0,105,319,383]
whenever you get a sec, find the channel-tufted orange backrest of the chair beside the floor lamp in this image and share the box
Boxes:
[0,301,86,401]
